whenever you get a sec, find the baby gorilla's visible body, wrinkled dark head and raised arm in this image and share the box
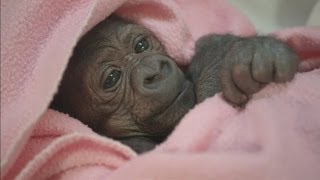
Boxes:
[51,17,298,153]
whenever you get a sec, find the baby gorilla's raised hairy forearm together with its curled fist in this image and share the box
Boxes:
[187,35,298,106]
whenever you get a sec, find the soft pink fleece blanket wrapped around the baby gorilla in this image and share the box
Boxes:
[1,0,320,180]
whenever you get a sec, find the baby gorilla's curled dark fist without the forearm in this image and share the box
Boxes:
[220,36,299,105]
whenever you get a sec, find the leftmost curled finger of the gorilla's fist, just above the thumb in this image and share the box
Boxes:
[232,64,261,95]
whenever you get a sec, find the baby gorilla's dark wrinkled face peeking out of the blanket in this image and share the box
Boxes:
[52,17,195,138]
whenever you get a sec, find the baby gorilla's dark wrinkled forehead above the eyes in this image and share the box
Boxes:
[74,17,152,63]
